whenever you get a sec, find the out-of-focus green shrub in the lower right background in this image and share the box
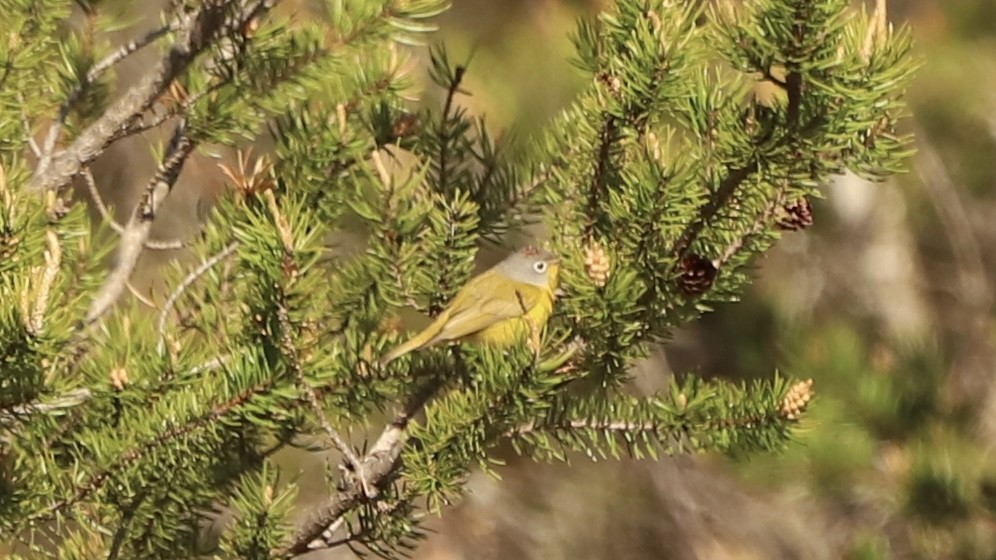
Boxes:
[741,322,996,559]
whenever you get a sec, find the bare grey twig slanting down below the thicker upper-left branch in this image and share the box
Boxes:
[83,122,194,326]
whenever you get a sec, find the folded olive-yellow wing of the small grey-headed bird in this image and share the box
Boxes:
[433,281,541,342]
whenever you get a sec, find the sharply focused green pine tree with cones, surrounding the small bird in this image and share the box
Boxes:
[0,0,913,558]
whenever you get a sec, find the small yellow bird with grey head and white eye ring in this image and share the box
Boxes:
[380,247,560,363]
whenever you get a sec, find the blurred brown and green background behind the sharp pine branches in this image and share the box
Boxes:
[85,0,996,560]
